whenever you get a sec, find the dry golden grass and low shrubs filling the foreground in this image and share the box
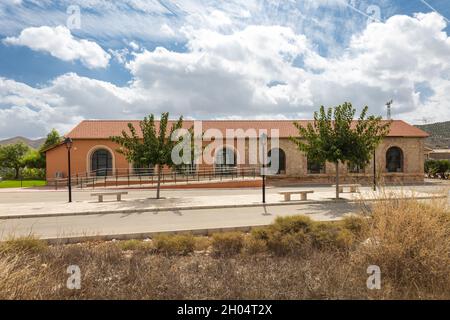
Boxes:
[0,195,450,299]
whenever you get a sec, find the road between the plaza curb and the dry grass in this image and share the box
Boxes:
[0,203,359,239]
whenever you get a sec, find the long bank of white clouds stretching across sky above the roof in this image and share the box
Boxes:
[0,13,450,137]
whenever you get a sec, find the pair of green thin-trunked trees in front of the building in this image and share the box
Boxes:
[111,102,391,199]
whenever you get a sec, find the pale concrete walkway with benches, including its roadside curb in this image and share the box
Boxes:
[0,187,439,219]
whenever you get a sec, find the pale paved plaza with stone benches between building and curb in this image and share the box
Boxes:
[0,186,443,218]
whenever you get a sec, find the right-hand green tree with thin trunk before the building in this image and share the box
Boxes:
[290,102,391,199]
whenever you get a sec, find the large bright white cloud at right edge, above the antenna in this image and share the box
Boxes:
[312,13,450,121]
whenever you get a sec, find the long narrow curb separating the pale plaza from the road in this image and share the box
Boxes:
[0,195,447,220]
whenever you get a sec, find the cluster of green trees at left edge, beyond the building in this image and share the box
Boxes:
[0,129,61,179]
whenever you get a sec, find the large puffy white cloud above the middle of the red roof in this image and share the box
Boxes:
[128,26,312,117]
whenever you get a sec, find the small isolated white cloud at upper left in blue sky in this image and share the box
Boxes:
[3,26,111,69]
